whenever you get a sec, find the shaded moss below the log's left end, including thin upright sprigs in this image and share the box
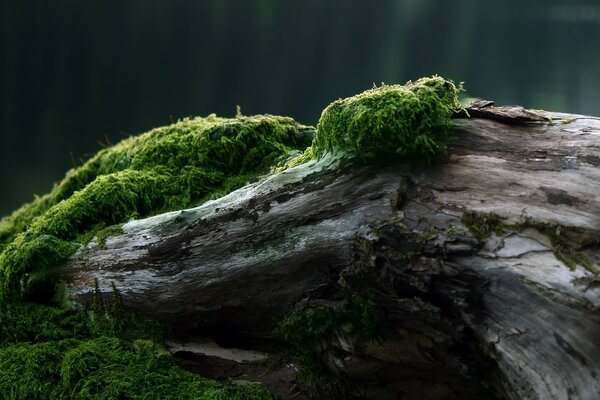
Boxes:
[0,300,273,400]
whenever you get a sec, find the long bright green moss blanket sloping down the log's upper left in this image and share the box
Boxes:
[0,115,311,295]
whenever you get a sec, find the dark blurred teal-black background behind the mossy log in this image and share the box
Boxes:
[0,0,600,215]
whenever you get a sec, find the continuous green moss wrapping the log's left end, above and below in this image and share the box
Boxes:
[0,115,310,400]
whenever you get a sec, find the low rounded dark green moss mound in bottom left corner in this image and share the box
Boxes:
[0,337,272,400]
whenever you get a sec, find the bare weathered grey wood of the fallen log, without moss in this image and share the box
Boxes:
[61,106,600,399]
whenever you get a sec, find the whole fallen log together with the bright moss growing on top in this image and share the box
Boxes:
[0,77,600,399]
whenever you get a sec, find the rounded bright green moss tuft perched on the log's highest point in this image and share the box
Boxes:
[313,76,461,161]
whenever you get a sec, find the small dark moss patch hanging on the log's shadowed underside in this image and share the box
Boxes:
[274,295,382,389]
